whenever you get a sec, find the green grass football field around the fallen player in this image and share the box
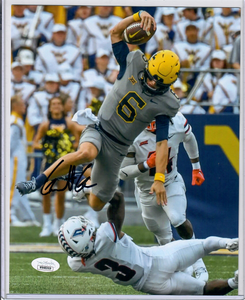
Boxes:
[9,226,238,296]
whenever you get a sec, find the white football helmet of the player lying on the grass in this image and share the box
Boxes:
[58,216,96,257]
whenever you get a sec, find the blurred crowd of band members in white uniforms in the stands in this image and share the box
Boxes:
[10,5,241,229]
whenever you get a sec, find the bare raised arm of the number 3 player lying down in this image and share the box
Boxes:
[107,192,125,239]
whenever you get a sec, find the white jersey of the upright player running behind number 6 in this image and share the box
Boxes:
[128,112,192,192]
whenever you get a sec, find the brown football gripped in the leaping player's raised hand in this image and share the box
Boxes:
[122,22,155,45]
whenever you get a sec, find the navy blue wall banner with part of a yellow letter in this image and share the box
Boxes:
[176,114,239,239]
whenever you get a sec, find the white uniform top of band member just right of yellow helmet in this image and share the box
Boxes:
[172,42,212,69]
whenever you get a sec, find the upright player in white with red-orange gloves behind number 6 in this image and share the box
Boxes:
[119,112,208,281]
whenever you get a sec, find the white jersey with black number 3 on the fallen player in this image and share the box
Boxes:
[68,222,152,290]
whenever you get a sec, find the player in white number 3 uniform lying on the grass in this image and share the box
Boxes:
[58,192,238,295]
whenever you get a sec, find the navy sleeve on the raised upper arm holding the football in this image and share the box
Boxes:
[112,41,129,79]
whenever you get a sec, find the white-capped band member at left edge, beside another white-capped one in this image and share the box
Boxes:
[11,61,36,104]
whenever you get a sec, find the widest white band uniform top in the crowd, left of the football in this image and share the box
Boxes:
[35,43,83,81]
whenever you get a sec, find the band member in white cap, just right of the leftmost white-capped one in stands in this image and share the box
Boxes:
[17,49,44,87]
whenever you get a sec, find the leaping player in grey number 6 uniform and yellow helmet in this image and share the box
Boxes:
[16,11,180,211]
